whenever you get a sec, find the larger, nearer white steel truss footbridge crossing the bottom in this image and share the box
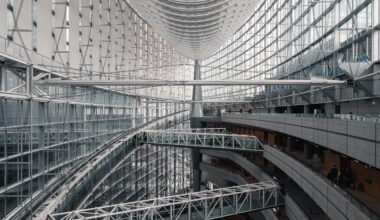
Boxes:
[48,182,283,220]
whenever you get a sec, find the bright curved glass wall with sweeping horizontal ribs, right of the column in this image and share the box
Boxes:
[202,0,375,100]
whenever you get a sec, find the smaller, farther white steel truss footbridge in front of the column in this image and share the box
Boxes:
[140,130,263,152]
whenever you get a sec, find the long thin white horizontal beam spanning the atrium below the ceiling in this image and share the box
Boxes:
[34,79,346,86]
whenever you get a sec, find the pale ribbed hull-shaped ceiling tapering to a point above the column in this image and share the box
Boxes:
[127,0,257,60]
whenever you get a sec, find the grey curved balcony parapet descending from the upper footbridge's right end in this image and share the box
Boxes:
[264,145,379,219]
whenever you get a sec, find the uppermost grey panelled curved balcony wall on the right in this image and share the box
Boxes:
[222,114,380,168]
